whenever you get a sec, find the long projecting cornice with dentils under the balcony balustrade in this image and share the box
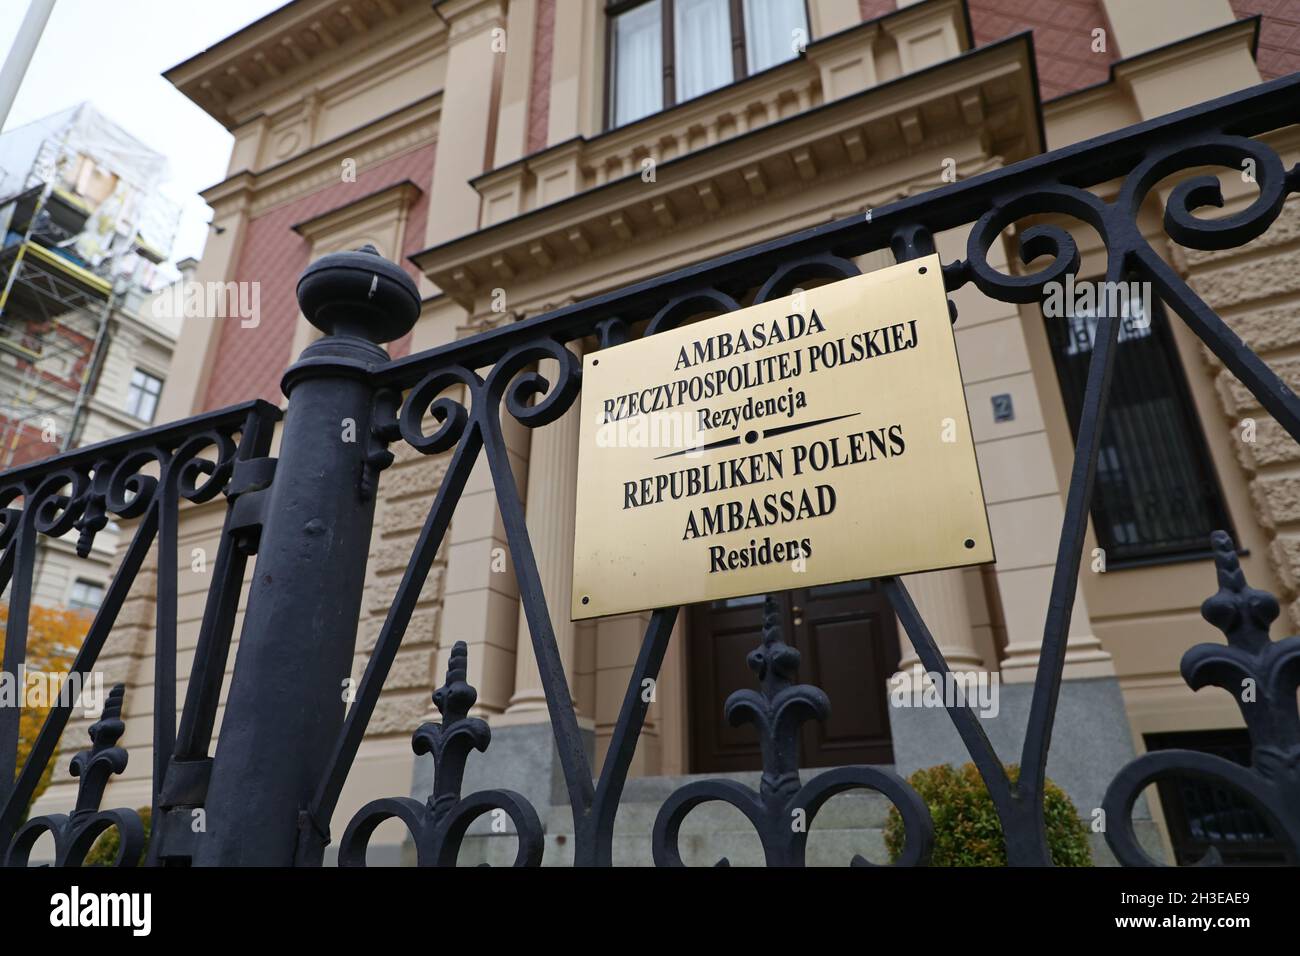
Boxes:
[411,34,1040,312]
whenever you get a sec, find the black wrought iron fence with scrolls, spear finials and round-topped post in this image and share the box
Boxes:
[0,70,1300,865]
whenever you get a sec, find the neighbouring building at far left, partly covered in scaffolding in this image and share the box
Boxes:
[0,103,181,611]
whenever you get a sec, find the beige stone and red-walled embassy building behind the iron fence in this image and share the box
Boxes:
[35,0,1300,864]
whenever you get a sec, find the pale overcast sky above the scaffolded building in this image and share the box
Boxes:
[0,0,285,261]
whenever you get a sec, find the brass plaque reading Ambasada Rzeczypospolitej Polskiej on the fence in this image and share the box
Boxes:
[573,256,993,620]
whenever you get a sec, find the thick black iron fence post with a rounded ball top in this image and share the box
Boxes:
[195,246,420,866]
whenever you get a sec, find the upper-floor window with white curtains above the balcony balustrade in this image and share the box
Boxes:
[607,0,807,126]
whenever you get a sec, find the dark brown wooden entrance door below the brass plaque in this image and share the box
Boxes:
[686,581,898,774]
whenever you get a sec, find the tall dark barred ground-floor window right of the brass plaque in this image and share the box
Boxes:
[1047,282,1232,568]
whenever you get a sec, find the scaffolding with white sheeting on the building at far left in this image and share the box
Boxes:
[0,103,179,468]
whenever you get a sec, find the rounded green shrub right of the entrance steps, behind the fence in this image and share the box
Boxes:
[885,763,1092,866]
